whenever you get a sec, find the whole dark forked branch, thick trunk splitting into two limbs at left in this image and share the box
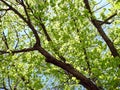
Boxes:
[0,0,110,90]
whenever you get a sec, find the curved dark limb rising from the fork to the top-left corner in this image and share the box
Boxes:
[1,0,40,46]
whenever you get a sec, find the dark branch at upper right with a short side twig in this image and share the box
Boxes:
[84,0,119,57]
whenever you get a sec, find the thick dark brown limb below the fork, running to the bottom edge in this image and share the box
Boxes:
[37,47,99,90]
